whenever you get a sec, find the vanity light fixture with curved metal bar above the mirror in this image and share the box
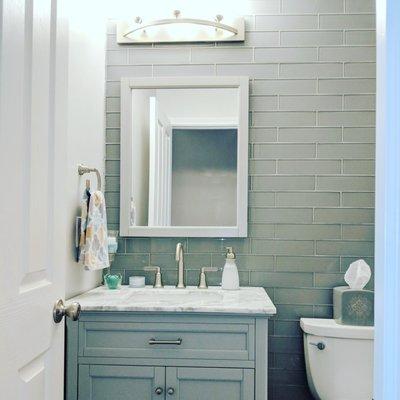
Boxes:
[117,10,244,44]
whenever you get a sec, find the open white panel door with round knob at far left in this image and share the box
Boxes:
[0,0,67,400]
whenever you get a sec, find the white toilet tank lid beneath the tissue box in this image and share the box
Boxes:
[300,318,374,339]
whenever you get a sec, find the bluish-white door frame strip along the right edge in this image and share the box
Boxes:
[374,0,400,400]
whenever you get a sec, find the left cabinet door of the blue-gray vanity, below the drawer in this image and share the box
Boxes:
[78,365,165,400]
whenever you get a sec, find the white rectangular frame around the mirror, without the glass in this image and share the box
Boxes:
[120,76,249,238]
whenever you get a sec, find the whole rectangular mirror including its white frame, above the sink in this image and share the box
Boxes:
[120,77,249,237]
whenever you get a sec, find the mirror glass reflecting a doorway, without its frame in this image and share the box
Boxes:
[130,88,239,227]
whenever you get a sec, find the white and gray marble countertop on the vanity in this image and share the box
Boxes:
[67,285,276,315]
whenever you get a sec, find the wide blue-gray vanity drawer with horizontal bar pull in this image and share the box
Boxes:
[79,322,254,360]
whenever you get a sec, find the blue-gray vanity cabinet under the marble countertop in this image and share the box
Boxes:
[66,311,268,400]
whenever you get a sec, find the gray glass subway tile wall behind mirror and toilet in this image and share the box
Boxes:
[106,0,375,400]
